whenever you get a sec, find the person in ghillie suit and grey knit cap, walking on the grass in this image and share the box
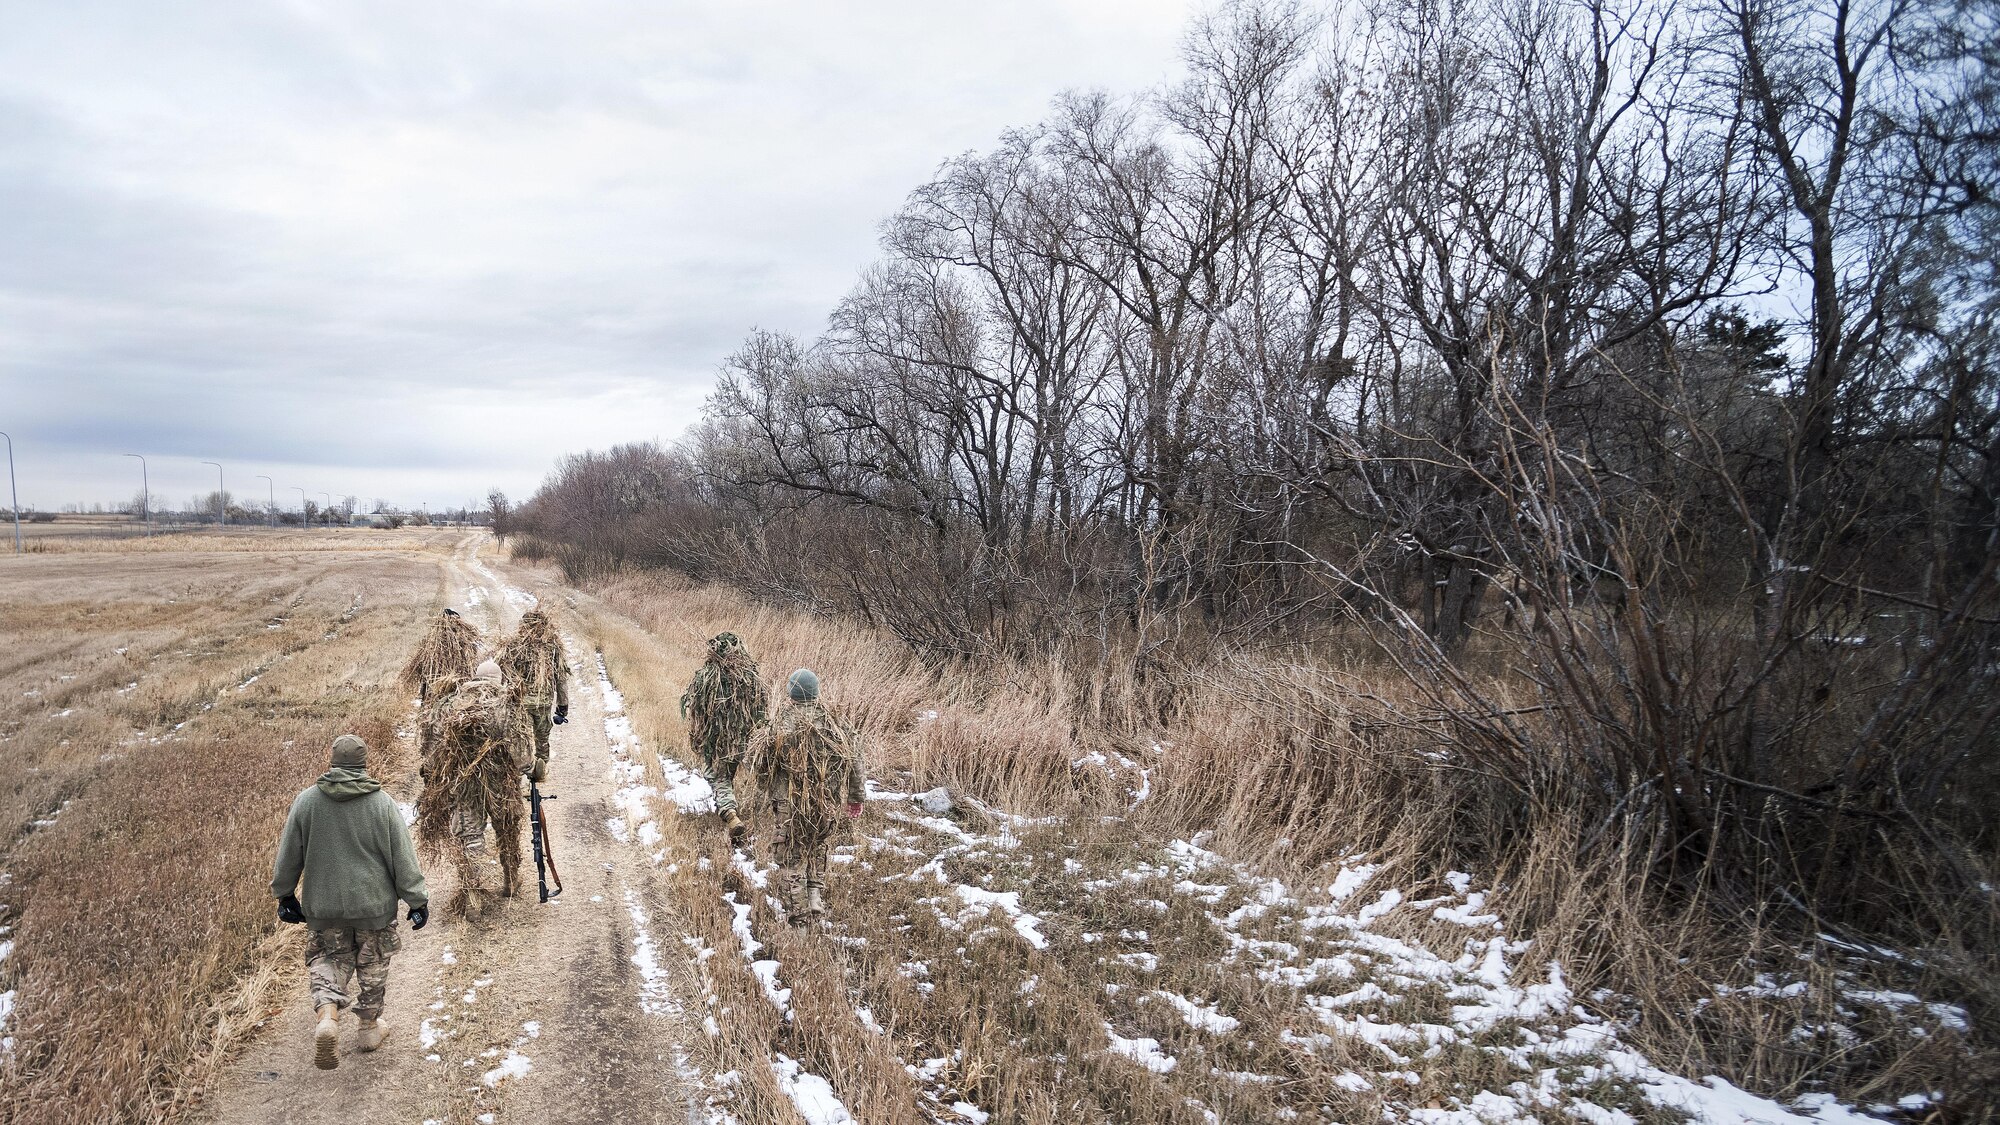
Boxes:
[758,669,866,915]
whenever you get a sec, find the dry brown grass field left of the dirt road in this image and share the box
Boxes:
[0,540,450,1123]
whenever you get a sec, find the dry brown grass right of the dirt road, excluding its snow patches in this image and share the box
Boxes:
[568,577,1994,1123]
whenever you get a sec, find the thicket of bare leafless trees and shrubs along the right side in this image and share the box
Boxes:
[516,0,2000,972]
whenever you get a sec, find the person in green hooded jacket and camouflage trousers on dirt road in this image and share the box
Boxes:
[270,735,430,1071]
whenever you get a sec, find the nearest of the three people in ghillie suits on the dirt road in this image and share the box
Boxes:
[416,661,534,915]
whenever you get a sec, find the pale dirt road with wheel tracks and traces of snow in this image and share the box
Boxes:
[212,534,704,1125]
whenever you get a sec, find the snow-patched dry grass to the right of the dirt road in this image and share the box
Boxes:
[576,579,1972,1125]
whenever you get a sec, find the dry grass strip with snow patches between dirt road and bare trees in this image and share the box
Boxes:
[576,577,1990,1125]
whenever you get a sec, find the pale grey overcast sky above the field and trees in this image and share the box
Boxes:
[0,0,1190,508]
